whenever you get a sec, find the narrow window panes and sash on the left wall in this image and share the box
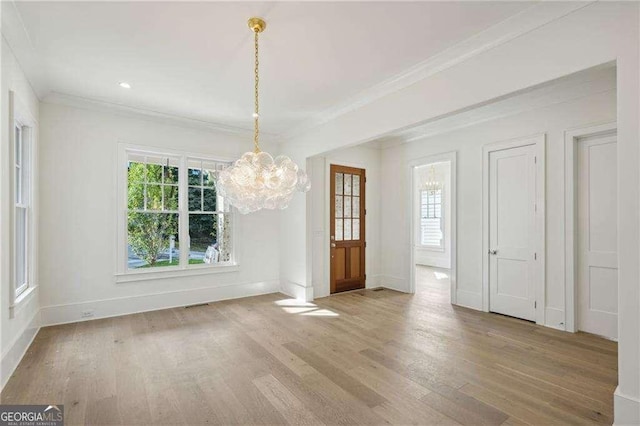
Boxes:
[13,122,31,297]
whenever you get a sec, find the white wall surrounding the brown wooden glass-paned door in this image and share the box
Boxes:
[309,147,381,298]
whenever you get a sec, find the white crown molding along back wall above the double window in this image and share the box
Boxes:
[42,92,273,141]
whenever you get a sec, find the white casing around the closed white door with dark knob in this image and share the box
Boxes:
[482,133,546,324]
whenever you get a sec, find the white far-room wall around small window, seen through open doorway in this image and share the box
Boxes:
[412,161,451,269]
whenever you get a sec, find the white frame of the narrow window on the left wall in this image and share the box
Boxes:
[9,91,38,310]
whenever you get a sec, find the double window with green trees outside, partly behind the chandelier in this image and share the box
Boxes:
[126,151,233,270]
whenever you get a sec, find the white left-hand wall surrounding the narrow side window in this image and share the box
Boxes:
[0,38,39,387]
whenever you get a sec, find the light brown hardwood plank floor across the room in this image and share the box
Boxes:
[0,268,617,425]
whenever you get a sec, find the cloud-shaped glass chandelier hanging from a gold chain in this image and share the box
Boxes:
[216,18,311,214]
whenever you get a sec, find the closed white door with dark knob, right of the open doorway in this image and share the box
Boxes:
[489,145,536,321]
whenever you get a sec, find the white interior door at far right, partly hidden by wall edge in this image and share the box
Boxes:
[577,136,618,339]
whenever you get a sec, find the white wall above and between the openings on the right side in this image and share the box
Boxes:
[382,87,616,329]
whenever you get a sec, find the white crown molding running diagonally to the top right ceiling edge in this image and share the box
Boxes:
[280,1,594,141]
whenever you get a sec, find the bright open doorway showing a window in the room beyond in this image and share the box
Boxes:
[410,152,456,303]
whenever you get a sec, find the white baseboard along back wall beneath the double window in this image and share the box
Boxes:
[41,280,280,326]
